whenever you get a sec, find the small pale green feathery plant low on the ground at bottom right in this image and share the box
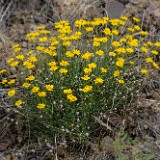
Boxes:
[113,130,156,160]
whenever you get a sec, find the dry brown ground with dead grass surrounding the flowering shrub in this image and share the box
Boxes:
[0,0,160,160]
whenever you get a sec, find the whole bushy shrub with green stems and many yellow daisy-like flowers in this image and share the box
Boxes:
[0,17,160,142]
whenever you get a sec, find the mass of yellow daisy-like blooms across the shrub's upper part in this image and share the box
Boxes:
[4,16,160,109]
